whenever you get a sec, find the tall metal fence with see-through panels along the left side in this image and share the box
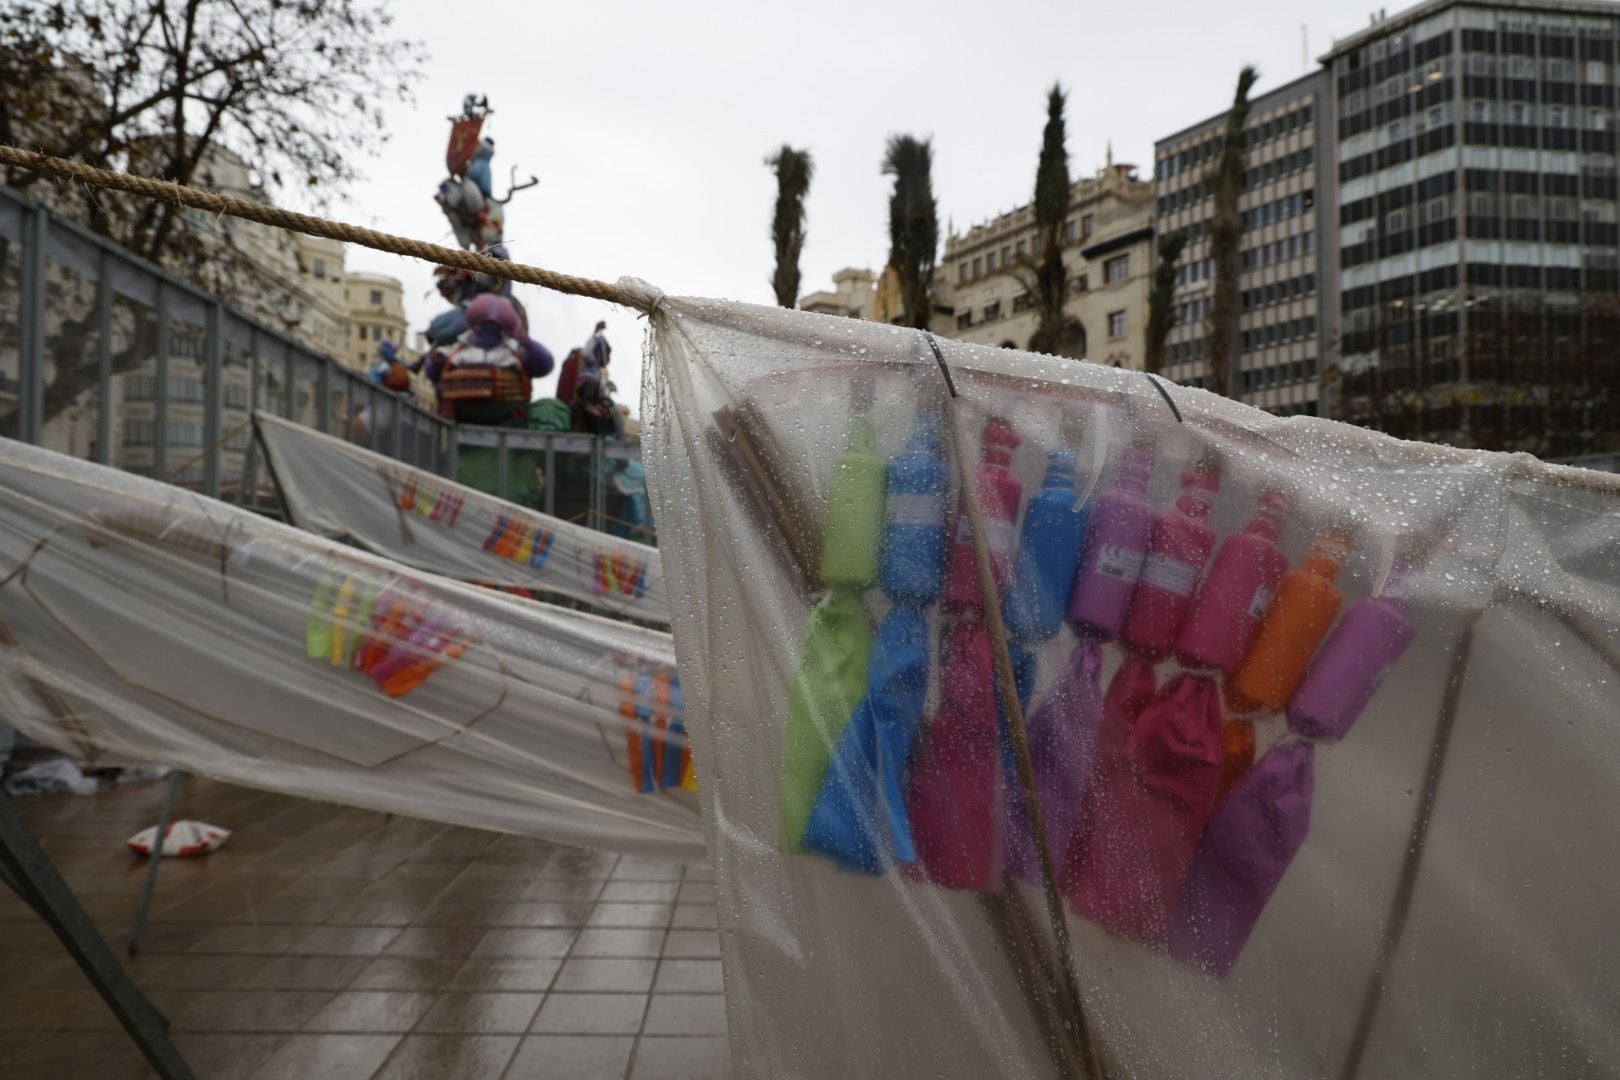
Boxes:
[0,186,455,508]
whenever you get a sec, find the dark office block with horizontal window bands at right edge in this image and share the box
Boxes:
[1324,0,1620,457]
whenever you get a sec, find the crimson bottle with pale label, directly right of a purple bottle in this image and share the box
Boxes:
[1119,457,1220,662]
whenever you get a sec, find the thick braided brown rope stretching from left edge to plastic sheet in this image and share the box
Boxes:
[0,146,650,311]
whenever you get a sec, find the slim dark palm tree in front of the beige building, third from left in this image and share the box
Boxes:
[1019,83,1085,356]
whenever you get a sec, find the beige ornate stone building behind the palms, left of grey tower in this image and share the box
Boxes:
[933,155,1153,368]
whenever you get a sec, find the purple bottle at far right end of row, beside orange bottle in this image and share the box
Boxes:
[1288,565,1418,738]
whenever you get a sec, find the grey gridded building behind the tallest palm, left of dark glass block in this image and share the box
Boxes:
[1153,71,1333,416]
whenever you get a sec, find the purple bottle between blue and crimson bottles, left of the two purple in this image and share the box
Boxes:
[1068,445,1153,640]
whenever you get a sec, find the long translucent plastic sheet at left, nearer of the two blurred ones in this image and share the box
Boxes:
[0,440,703,858]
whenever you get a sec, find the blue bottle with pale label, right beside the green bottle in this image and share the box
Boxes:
[878,411,951,607]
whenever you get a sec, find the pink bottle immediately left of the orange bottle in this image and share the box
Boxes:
[1176,491,1290,674]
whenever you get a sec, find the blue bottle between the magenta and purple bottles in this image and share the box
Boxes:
[1006,450,1090,643]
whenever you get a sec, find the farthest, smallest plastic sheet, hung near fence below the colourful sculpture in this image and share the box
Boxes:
[253,411,669,625]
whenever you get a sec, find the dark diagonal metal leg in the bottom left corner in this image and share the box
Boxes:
[0,792,193,1080]
